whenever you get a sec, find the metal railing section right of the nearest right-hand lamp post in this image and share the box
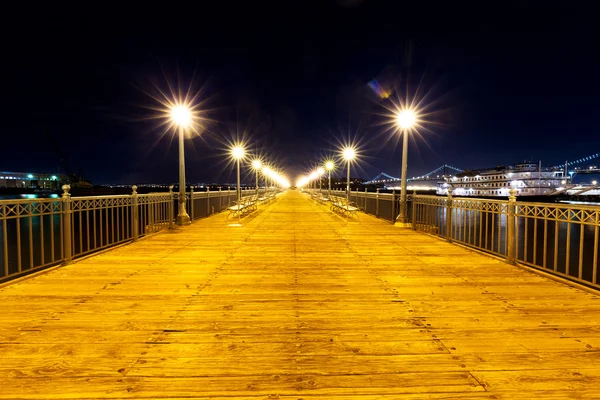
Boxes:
[412,193,600,288]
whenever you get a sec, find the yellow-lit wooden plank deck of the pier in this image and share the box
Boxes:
[0,191,600,400]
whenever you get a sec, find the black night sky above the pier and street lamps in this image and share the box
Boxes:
[0,0,600,184]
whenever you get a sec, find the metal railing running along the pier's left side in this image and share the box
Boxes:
[0,185,268,282]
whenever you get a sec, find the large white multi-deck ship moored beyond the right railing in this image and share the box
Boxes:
[437,162,569,197]
